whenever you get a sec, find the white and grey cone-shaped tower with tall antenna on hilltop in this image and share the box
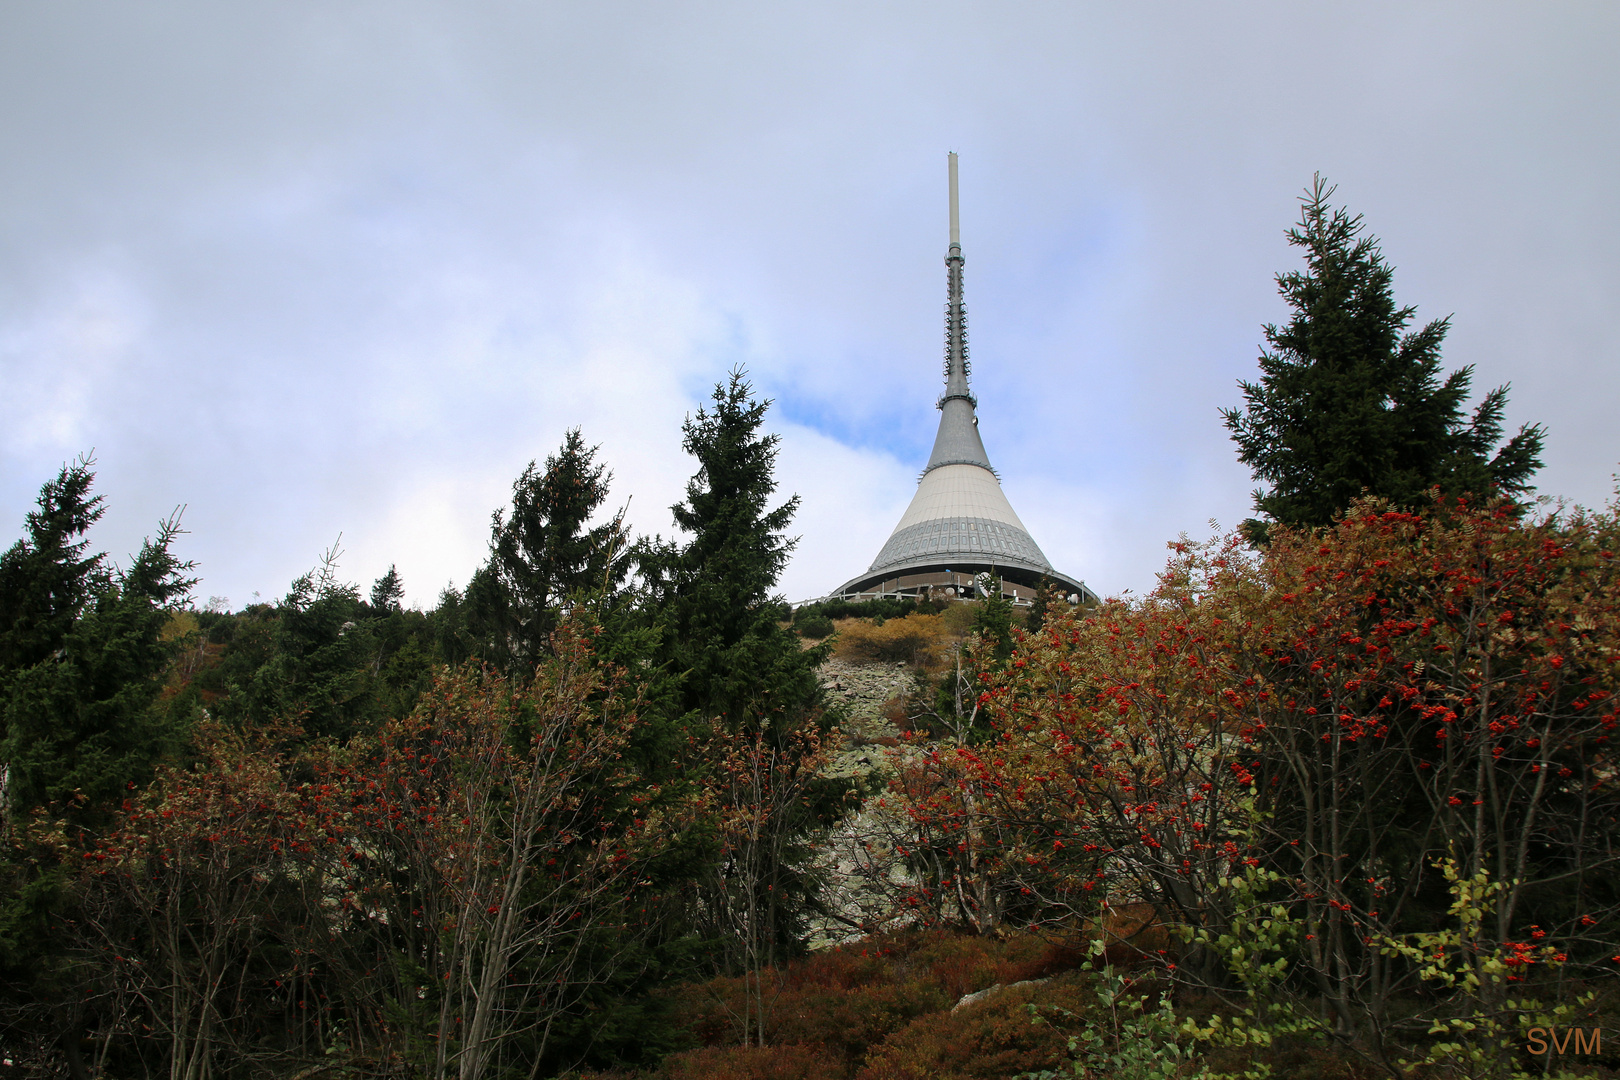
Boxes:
[833,154,1097,604]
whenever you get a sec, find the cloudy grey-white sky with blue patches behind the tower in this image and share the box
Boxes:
[0,0,1620,606]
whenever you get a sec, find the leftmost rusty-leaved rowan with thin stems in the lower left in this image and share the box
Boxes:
[72,721,312,1077]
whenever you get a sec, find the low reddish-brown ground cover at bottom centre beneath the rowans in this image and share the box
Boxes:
[578,908,1555,1080]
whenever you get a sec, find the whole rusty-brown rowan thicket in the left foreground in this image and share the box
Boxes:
[58,625,687,1077]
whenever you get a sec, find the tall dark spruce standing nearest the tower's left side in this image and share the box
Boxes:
[640,371,852,973]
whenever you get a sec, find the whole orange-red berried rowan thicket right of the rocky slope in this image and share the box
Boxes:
[891,500,1620,1046]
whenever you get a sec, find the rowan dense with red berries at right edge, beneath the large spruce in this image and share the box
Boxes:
[1234,502,1620,1038]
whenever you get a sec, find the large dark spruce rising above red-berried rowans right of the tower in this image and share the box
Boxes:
[1221,176,1545,539]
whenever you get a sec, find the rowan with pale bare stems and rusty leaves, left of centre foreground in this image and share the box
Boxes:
[313,620,667,1080]
